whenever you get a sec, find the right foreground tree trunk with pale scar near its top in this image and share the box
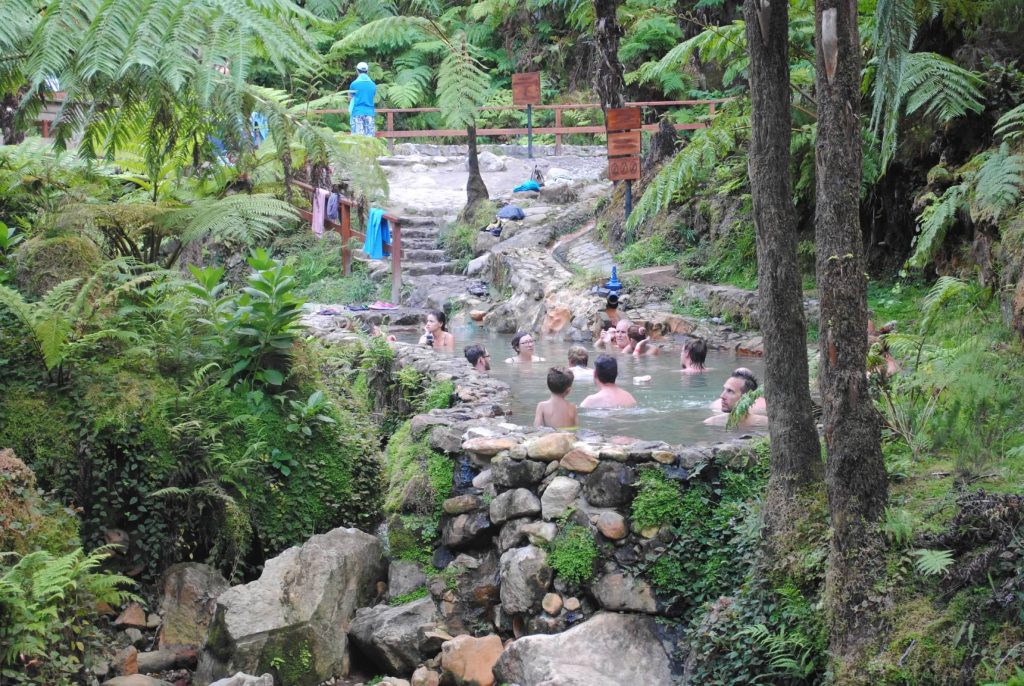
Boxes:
[814,0,888,684]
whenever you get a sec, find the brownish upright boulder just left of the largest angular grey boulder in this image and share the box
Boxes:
[160,562,230,649]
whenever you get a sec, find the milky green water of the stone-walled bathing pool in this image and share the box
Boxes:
[398,325,764,444]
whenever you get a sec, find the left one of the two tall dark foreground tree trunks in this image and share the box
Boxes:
[744,0,824,539]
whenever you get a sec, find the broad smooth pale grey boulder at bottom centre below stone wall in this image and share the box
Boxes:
[495,613,672,686]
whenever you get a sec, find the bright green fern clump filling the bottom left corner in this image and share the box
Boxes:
[0,548,135,686]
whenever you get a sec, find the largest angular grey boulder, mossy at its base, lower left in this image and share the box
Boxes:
[195,528,386,686]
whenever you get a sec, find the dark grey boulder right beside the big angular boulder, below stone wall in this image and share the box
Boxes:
[348,598,441,674]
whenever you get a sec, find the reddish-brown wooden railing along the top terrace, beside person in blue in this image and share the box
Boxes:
[312,98,731,155]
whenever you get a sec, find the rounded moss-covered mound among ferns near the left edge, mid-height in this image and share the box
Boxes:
[14,235,103,297]
